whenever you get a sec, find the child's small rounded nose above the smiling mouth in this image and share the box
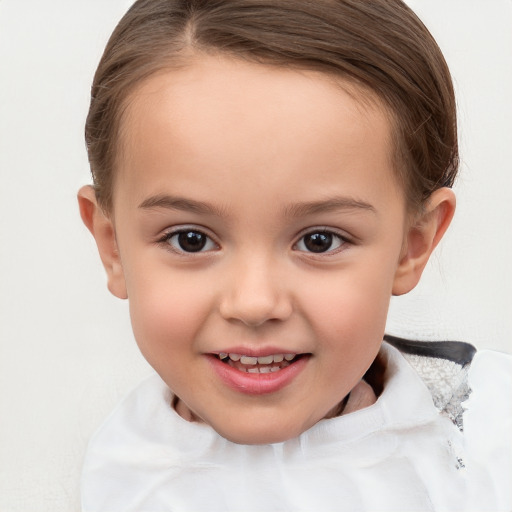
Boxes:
[220,257,293,327]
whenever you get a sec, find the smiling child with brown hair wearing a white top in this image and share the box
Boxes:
[79,0,512,512]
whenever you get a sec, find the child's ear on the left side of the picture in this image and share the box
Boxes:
[78,185,128,299]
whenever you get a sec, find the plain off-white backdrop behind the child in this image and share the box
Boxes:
[0,0,512,512]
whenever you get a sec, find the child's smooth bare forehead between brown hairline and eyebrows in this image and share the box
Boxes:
[114,57,402,212]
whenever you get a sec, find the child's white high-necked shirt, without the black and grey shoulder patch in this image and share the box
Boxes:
[82,344,512,512]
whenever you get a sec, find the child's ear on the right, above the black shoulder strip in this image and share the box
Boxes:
[393,188,455,295]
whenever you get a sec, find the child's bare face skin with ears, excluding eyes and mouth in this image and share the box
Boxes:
[79,56,455,444]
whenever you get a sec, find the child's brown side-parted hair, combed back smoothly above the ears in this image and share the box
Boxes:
[85,0,458,211]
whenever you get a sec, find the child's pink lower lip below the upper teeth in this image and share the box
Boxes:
[208,355,310,395]
